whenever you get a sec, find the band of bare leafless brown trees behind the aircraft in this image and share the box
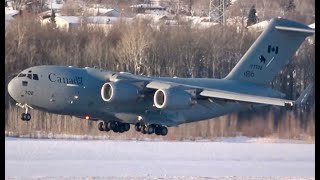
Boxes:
[5,17,315,139]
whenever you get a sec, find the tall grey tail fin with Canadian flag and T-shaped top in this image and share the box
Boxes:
[225,18,315,85]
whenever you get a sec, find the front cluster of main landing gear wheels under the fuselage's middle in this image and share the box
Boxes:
[98,121,130,133]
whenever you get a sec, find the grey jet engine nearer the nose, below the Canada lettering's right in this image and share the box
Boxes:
[101,82,139,103]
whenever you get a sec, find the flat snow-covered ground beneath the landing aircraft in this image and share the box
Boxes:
[5,137,315,180]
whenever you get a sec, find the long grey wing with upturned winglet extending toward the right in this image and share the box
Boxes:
[147,81,313,106]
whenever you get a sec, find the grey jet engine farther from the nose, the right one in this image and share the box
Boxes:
[153,89,192,109]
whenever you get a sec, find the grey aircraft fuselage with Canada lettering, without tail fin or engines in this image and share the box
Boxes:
[8,65,283,126]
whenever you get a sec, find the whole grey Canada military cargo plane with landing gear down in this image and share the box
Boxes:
[8,18,314,136]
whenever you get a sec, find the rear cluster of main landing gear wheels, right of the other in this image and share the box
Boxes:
[135,122,168,136]
